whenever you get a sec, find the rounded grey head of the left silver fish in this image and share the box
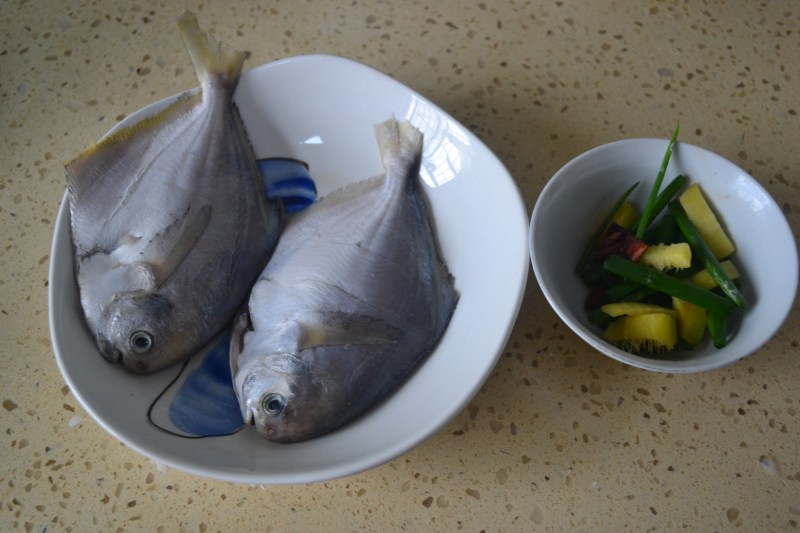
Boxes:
[96,291,190,374]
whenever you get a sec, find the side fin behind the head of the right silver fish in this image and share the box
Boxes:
[297,311,405,350]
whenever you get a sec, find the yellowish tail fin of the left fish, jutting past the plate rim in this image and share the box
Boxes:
[177,11,246,87]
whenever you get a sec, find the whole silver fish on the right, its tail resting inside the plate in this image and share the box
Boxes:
[230,119,458,443]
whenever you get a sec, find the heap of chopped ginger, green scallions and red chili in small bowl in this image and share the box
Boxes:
[576,125,745,352]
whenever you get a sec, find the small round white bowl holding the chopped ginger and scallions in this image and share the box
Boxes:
[528,139,798,373]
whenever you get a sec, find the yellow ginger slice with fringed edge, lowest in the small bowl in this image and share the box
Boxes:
[605,313,678,352]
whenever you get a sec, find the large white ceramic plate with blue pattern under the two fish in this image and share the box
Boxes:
[49,56,528,484]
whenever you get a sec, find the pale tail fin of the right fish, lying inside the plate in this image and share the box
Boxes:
[375,117,423,191]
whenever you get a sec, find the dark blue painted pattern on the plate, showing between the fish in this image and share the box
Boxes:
[169,158,317,436]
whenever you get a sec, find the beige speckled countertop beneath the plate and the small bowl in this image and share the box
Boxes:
[0,0,800,532]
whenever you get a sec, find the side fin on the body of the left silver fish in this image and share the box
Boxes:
[139,205,211,287]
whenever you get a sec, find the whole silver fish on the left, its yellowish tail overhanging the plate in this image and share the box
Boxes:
[66,12,282,374]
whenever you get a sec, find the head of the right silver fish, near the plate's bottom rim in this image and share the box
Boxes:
[234,353,325,443]
